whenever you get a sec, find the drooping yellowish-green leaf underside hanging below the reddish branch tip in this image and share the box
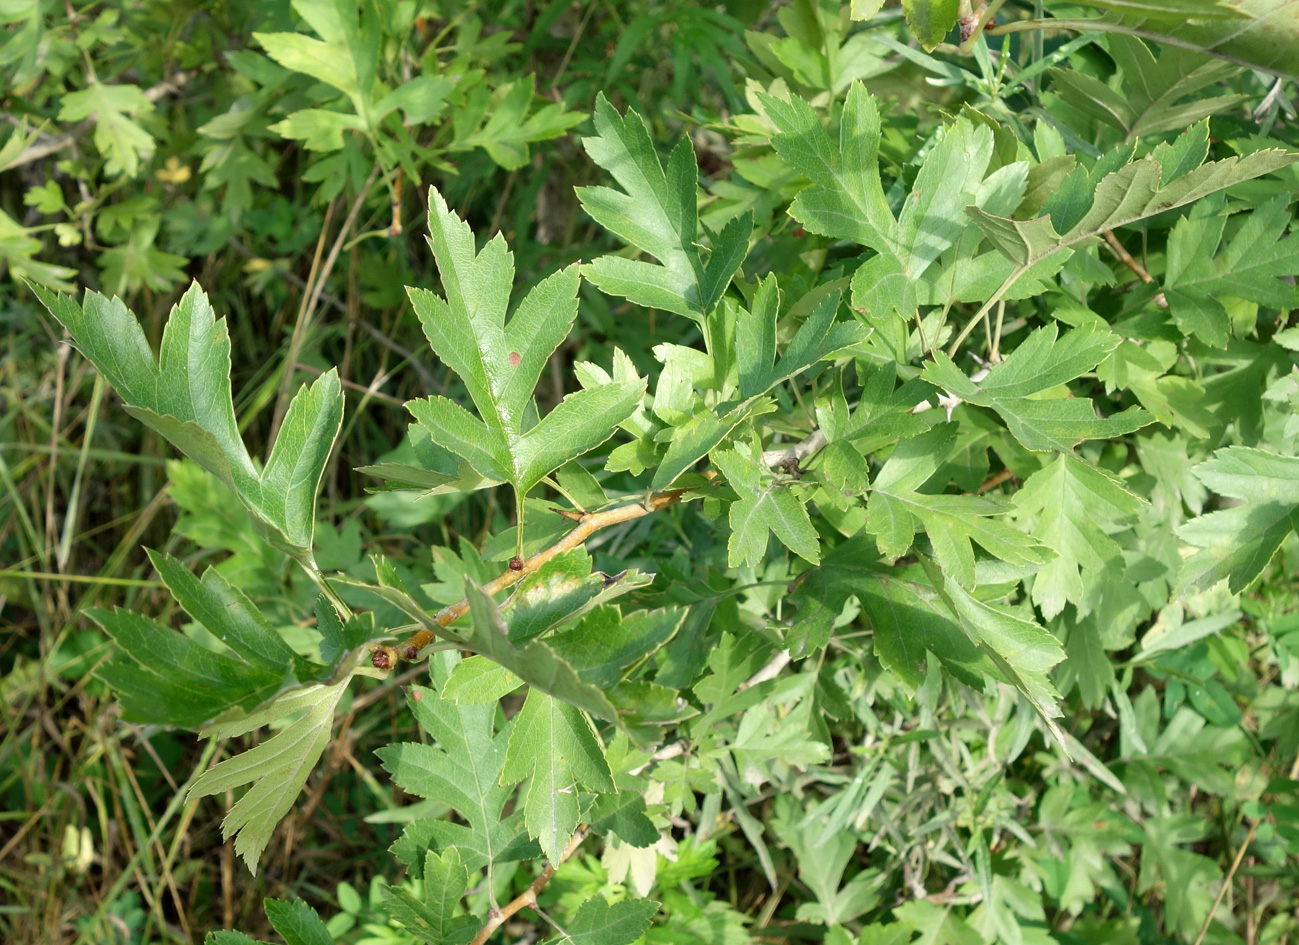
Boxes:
[187,676,351,875]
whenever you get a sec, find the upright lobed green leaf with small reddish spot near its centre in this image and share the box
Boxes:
[407,190,644,495]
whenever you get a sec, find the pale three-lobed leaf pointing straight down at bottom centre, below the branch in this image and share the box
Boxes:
[500,689,614,863]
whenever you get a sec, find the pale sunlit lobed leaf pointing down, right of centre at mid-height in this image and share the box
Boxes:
[1015,455,1146,619]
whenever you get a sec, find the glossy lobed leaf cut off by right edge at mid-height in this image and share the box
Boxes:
[1177,446,1299,594]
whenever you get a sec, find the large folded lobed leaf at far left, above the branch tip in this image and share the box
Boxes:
[35,285,343,562]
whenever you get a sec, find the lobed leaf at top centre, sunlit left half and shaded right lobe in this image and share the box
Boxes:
[577,92,753,322]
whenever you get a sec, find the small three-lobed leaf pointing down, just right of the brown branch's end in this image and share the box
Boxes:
[713,447,821,568]
